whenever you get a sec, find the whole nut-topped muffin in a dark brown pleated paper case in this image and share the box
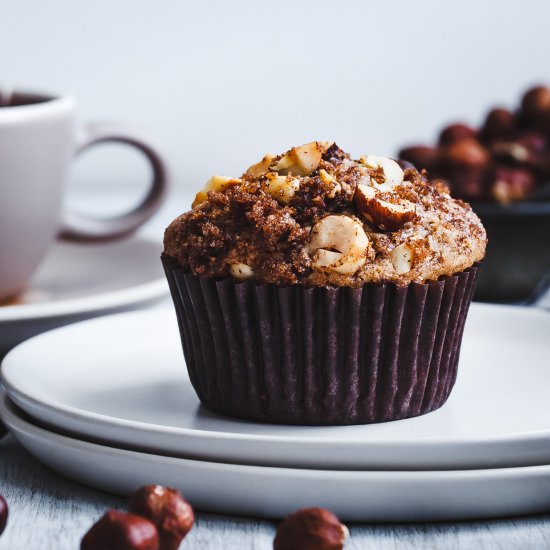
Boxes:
[162,142,487,425]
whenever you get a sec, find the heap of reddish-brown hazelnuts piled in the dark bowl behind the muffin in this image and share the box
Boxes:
[399,86,550,204]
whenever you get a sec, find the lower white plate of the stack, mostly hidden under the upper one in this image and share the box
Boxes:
[0,396,550,521]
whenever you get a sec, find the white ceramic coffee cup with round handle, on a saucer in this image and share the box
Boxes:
[0,89,168,301]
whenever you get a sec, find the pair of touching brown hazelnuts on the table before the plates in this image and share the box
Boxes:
[80,485,195,550]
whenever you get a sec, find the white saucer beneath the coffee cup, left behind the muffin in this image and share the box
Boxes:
[0,238,168,357]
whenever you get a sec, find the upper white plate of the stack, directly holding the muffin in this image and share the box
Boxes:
[2,304,550,470]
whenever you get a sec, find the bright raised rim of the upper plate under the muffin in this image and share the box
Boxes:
[0,303,550,448]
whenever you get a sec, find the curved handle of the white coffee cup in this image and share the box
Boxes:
[59,123,169,241]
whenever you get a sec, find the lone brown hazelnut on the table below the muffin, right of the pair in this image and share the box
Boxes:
[273,508,349,550]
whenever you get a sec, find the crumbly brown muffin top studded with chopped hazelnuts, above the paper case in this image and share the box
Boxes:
[164,141,487,287]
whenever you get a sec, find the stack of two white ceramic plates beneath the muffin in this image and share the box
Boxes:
[0,304,550,521]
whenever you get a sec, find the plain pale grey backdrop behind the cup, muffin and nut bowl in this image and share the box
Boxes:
[0,0,550,210]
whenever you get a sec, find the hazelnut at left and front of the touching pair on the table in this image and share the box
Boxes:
[80,510,160,550]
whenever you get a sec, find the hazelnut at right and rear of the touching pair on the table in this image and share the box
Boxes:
[128,485,195,550]
